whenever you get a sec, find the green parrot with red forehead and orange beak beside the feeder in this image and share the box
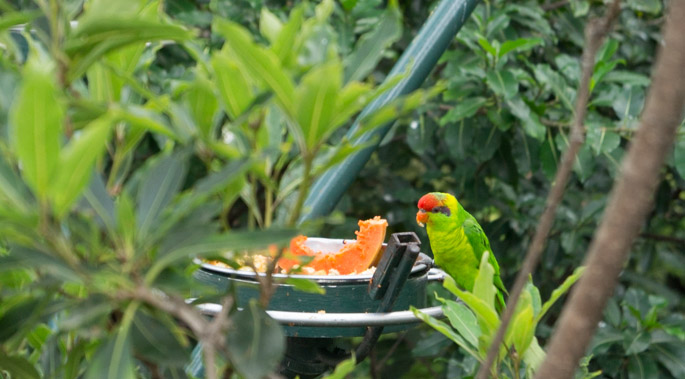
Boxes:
[416,192,508,312]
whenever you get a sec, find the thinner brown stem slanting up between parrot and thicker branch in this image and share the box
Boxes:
[476,0,621,379]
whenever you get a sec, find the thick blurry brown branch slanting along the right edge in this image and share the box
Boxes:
[536,0,685,378]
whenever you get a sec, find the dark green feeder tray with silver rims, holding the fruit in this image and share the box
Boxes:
[195,233,442,338]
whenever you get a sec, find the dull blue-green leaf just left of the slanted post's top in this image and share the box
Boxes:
[344,1,402,83]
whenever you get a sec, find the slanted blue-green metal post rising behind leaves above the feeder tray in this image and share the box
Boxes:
[300,0,480,222]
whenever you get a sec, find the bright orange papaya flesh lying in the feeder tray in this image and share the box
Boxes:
[278,216,388,275]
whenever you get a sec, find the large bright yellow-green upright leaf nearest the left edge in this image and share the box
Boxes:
[11,55,65,200]
